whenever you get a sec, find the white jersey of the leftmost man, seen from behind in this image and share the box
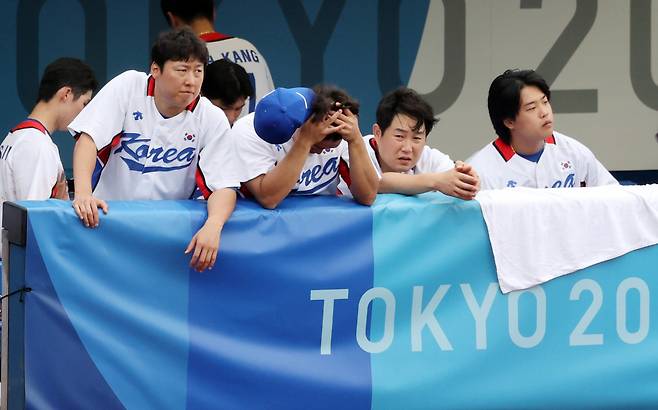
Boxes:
[0,119,68,229]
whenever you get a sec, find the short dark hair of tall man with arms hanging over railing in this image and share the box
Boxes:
[151,27,208,69]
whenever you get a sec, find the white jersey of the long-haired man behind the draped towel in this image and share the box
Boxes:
[467,132,617,189]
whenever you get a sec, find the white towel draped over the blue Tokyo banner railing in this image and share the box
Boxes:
[476,184,658,293]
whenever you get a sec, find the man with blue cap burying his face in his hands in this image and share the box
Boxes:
[231,86,379,209]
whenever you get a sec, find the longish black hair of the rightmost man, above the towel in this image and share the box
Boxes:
[487,69,551,144]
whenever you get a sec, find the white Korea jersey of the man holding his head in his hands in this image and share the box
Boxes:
[230,113,349,195]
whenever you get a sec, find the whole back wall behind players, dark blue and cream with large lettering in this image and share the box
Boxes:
[0,0,658,177]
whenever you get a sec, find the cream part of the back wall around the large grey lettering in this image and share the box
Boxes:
[409,0,658,170]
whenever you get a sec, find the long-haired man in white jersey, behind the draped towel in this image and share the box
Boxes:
[469,70,617,189]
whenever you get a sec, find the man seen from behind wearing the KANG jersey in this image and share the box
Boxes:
[160,0,274,117]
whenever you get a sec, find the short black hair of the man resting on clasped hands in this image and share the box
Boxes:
[376,87,439,136]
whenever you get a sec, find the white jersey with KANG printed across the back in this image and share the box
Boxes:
[201,33,274,117]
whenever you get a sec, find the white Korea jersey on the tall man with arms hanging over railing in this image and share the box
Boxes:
[68,71,240,200]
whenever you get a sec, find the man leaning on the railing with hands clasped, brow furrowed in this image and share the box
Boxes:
[339,87,479,200]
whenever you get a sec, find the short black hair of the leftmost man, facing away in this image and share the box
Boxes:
[37,57,98,102]
